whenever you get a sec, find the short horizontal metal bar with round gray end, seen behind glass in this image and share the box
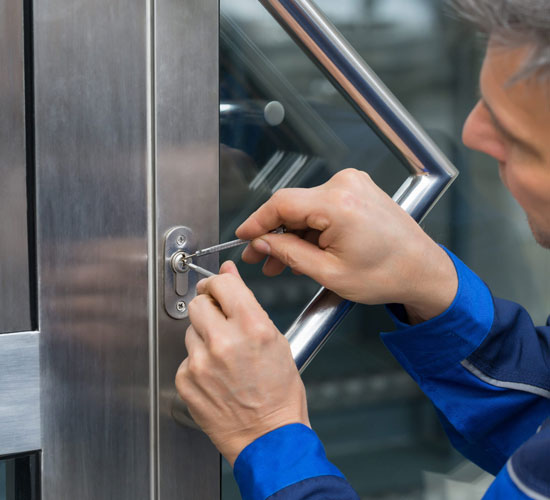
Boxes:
[220,100,285,127]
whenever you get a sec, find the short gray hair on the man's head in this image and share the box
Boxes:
[450,0,550,80]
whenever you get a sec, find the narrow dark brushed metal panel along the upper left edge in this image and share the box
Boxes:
[0,0,32,333]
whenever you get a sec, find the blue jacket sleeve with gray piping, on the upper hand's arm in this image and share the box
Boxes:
[382,248,550,474]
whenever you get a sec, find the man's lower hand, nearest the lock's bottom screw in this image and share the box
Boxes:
[176,262,310,465]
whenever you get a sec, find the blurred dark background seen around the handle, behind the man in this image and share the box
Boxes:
[220,0,550,500]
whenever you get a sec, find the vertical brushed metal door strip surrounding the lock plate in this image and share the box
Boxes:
[155,0,220,500]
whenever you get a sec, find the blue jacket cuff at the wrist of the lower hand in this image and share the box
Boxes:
[233,424,359,500]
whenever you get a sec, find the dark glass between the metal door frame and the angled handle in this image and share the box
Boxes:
[220,0,407,336]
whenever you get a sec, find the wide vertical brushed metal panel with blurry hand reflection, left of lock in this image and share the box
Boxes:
[34,0,153,500]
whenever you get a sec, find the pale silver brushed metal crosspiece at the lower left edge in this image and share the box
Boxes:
[0,332,40,456]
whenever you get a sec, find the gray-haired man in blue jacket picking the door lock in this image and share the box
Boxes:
[176,0,550,500]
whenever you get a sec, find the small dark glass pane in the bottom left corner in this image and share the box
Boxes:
[0,453,40,500]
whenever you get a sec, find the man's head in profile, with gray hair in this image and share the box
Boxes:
[453,0,550,248]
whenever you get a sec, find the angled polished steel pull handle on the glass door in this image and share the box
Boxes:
[259,0,458,370]
